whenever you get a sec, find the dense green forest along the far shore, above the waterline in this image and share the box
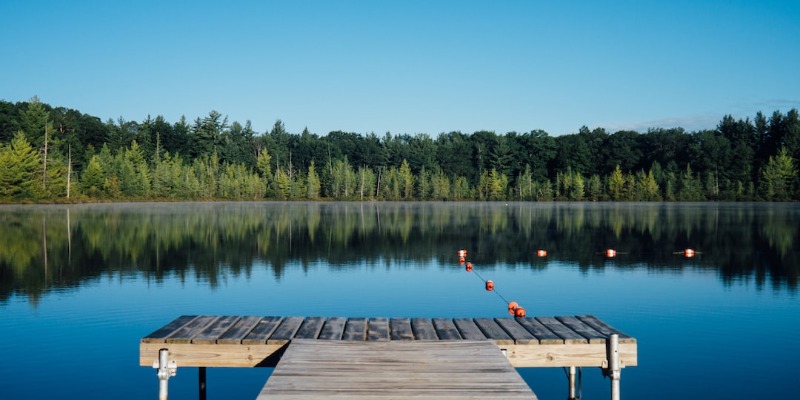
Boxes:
[0,97,800,202]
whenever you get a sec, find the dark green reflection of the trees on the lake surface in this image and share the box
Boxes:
[0,202,800,303]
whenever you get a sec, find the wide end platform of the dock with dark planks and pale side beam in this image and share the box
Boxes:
[139,315,637,367]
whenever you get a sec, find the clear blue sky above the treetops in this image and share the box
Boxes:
[0,0,800,136]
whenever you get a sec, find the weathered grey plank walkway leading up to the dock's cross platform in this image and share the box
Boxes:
[258,340,536,400]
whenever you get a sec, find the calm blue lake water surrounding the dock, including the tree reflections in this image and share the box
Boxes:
[0,203,800,399]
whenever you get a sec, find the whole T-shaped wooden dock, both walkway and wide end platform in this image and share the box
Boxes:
[139,315,637,399]
